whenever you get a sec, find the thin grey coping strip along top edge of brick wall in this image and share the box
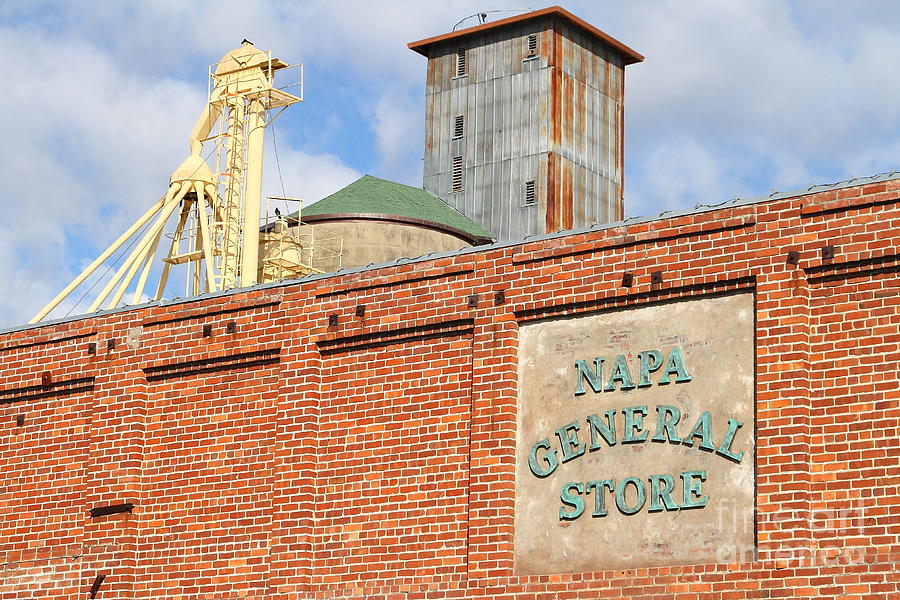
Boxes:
[0,171,900,335]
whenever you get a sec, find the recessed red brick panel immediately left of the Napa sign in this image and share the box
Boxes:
[314,335,472,595]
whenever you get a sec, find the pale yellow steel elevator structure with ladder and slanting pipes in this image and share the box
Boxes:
[30,40,303,323]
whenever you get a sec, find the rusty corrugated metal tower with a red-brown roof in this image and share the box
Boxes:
[409,6,643,240]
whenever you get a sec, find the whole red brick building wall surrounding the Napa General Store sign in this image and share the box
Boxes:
[0,180,900,600]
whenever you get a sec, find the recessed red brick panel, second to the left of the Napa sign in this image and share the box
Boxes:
[136,365,279,598]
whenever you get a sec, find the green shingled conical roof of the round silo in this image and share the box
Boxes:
[301,175,493,244]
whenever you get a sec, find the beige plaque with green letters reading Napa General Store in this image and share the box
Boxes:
[515,293,755,574]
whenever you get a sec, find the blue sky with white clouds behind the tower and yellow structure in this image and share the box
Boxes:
[0,0,900,327]
